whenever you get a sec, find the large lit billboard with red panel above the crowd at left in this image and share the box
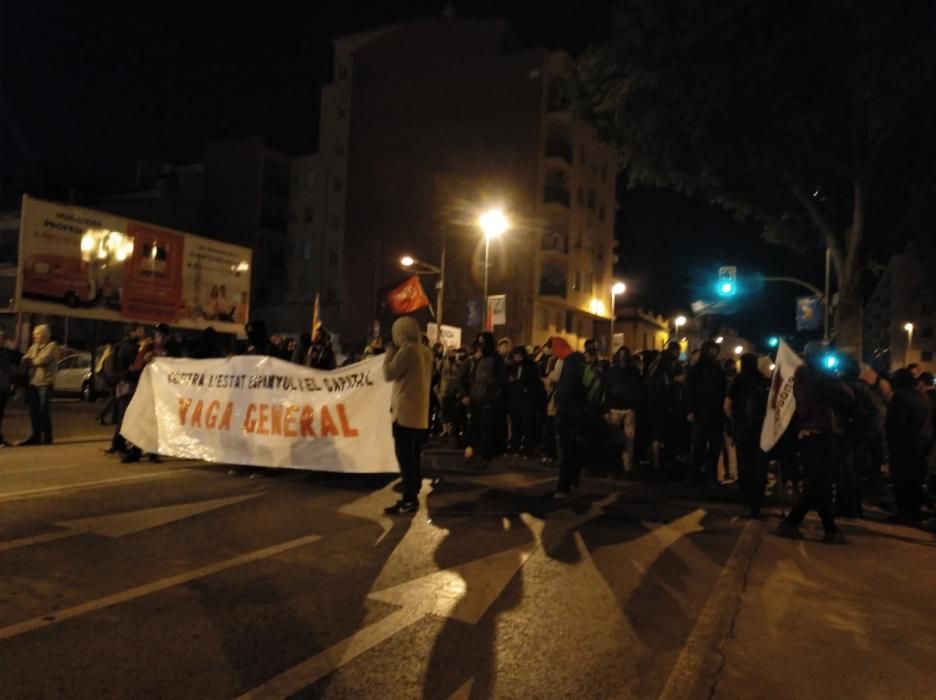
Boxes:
[16,196,251,333]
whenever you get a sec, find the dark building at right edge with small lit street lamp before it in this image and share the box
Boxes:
[864,246,936,372]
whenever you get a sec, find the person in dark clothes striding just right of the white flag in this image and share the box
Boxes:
[777,341,855,544]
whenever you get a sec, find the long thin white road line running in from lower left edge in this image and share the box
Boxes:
[0,535,321,640]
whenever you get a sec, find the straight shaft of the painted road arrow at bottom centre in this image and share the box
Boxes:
[236,606,428,700]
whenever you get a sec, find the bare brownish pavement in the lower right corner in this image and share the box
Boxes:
[712,517,936,699]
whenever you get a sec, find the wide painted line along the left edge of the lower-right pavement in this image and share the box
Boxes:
[660,521,761,700]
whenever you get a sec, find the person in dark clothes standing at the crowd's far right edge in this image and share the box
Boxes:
[885,369,933,525]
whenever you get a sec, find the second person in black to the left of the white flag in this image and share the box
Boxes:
[686,340,727,489]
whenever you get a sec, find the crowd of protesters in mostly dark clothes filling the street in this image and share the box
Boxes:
[0,318,936,542]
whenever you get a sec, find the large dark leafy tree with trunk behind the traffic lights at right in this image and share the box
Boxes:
[579,0,936,349]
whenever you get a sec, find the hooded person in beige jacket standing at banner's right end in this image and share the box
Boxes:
[384,316,432,515]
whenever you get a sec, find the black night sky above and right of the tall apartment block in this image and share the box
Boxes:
[0,0,872,340]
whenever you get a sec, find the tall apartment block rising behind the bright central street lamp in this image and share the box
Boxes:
[319,19,617,344]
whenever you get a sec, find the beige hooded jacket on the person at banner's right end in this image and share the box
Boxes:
[384,316,432,430]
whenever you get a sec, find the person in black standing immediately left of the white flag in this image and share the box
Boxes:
[725,353,770,518]
